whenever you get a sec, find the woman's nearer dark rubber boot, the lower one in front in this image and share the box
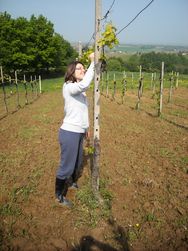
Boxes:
[55,178,73,207]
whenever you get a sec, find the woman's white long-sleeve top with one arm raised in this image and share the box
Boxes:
[61,62,94,133]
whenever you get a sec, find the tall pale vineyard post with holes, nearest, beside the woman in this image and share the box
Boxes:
[91,0,101,201]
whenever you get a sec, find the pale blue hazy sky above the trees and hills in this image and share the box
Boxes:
[0,0,188,46]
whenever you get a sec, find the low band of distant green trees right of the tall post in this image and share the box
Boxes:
[107,52,188,74]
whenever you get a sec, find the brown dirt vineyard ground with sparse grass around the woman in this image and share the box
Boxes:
[0,88,188,251]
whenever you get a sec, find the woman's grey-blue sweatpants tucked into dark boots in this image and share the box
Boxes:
[56,129,85,181]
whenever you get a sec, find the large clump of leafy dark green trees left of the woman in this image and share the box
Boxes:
[0,12,77,74]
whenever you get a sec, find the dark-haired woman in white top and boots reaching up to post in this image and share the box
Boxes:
[55,53,94,207]
